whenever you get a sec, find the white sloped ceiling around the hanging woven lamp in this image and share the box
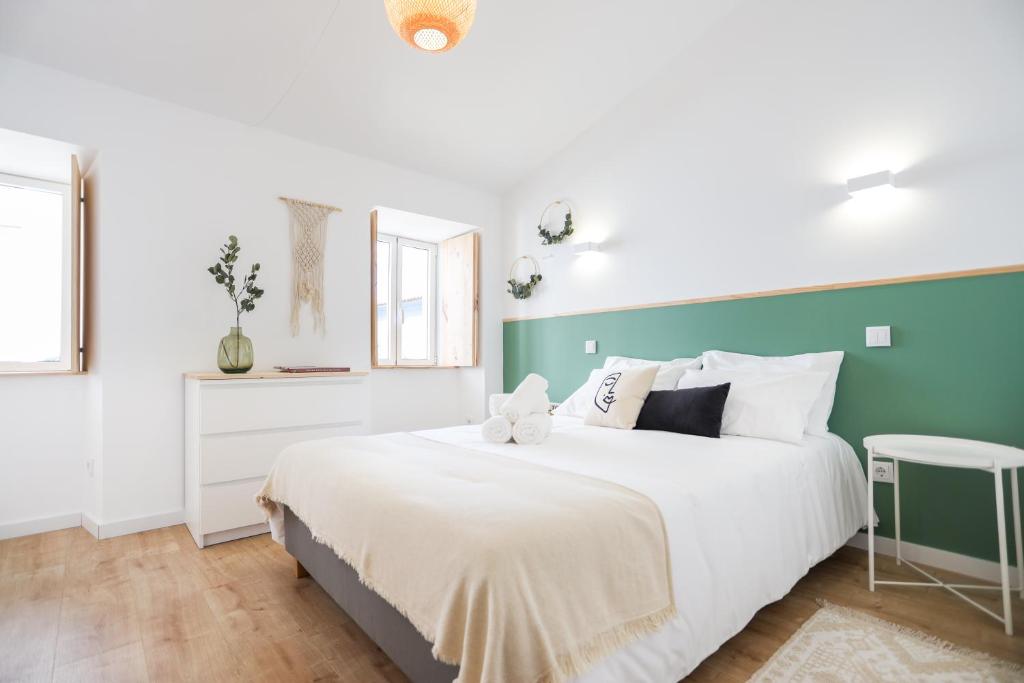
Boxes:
[0,0,739,189]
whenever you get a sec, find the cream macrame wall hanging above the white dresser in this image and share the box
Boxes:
[278,197,341,337]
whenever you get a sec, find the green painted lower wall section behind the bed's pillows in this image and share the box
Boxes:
[504,272,1024,562]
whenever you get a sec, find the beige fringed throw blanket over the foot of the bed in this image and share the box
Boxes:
[257,433,676,683]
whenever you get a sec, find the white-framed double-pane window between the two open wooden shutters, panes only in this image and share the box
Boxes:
[377,234,437,366]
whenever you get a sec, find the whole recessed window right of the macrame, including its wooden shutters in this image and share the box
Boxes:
[370,208,479,368]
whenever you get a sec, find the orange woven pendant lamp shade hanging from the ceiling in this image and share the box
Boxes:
[384,0,476,52]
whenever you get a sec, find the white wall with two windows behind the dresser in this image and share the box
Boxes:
[0,57,502,524]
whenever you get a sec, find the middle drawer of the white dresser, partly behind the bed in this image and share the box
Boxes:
[200,423,366,484]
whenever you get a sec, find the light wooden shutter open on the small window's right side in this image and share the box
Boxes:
[438,232,480,367]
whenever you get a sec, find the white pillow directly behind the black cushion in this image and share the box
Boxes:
[677,370,828,443]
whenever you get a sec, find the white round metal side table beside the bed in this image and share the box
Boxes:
[864,434,1024,636]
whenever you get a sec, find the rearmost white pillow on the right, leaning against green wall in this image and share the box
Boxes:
[702,351,844,436]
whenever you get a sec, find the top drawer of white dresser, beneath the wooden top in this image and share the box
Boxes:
[200,378,368,434]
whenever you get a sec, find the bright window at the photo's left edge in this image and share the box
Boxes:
[0,169,81,373]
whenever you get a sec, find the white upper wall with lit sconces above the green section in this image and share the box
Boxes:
[503,0,1024,315]
